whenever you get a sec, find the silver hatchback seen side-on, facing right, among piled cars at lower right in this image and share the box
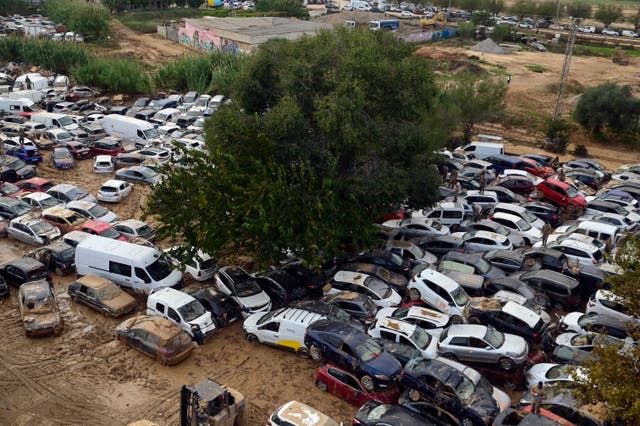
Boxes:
[438,324,529,371]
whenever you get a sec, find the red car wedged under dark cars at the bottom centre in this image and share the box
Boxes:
[315,364,400,407]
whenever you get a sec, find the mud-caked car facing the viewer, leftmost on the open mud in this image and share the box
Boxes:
[18,280,63,337]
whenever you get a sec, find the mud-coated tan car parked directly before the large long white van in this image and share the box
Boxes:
[67,274,137,317]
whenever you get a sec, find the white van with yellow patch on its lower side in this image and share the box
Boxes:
[242,308,327,357]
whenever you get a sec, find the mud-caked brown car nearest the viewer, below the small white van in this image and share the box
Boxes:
[116,315,193,365]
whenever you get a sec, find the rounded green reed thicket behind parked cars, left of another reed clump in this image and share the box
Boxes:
[72,59,152,94]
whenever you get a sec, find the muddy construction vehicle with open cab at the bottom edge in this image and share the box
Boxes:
[180,379,248,426]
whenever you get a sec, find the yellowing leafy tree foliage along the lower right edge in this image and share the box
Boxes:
[572,238,640,425]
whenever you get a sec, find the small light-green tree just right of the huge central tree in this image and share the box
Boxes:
[447,73,507,142]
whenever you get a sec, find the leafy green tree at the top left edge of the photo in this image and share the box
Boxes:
[42,0,110,41]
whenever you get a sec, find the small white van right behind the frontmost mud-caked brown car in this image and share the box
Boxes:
[147,288,216,344]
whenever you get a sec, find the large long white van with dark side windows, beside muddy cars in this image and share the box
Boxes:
[76,235,183,293]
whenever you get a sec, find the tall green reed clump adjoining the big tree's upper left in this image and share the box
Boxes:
[155,52,246,95]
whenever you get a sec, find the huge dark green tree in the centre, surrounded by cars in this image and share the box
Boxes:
[147,29,449,265]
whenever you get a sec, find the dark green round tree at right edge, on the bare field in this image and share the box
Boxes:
[574,83,640,136]
